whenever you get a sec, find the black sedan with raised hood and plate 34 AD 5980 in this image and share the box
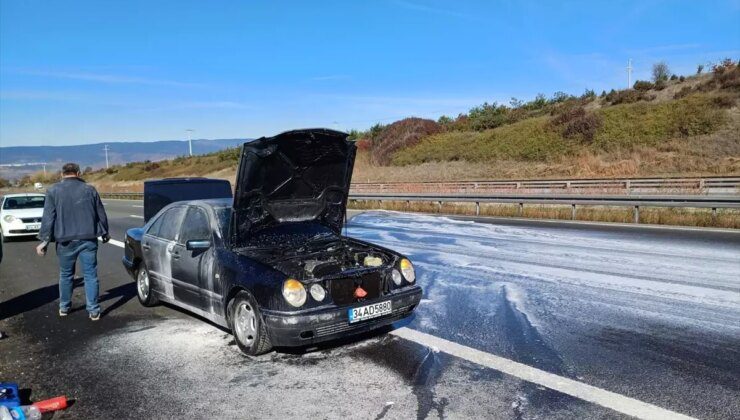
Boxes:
[123,129,422,354]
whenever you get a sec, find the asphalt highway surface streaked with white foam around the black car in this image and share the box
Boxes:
[0,200,740,419]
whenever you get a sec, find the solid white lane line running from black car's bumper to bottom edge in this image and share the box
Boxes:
[391,328,693,419]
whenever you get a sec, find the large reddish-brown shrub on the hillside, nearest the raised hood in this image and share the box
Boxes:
[371,118,443,165]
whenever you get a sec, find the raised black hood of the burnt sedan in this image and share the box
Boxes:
[231,129,356,246]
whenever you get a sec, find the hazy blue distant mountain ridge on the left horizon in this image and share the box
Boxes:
[0,139,248,179]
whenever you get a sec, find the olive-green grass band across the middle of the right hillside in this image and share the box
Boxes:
[392,94,729,165]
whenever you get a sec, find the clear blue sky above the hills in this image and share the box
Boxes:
[0,0,740,146]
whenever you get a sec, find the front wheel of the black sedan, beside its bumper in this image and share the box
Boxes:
[229,291,272,356]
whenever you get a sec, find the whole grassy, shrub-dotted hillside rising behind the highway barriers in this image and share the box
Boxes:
[11,60,740,190]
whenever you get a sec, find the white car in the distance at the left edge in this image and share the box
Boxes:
[0,194,46,239]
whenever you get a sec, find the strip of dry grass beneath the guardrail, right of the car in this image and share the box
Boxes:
[349,200,740,229]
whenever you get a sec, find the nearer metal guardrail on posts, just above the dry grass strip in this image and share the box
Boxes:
[100,192,740,223]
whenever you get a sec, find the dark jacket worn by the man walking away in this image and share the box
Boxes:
[39,178,108,242]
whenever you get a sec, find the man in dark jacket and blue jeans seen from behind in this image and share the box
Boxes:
[36,163,110,321]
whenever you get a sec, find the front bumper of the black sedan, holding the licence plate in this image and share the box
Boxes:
[262,286,422,347]
